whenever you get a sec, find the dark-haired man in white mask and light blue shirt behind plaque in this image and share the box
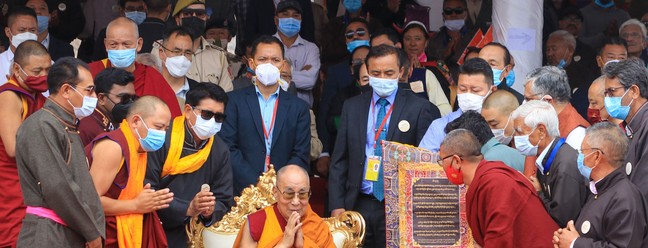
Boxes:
[419,58,497,152]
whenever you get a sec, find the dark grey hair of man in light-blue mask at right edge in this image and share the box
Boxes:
[603,58,648,98]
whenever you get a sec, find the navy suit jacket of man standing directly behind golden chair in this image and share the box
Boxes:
[218,86,311,195]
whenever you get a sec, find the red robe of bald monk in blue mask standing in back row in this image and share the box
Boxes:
[88,59,182,118]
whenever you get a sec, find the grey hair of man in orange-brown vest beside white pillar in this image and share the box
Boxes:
[524,66,571,103]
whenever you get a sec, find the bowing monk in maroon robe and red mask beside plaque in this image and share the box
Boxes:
[438,129,558,248]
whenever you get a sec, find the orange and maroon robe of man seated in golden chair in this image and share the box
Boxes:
[234,203,335,248]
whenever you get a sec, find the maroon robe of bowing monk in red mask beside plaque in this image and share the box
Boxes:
[466,160,558,248]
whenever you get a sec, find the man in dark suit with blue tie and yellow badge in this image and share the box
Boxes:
[329,45,440,247]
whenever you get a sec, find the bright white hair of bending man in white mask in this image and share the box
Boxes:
[511,100,560,137]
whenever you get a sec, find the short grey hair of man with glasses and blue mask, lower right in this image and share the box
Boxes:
[585,121,629,168]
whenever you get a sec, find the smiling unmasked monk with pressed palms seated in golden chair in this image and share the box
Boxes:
[234,165,335,248]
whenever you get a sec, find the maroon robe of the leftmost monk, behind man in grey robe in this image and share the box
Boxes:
[0,77,45,247]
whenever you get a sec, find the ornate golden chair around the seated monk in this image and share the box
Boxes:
[187,167,365,248]
